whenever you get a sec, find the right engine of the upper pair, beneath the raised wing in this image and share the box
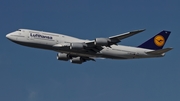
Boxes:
[94,38,111,46]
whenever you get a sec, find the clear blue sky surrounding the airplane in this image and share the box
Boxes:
[0,0,180,101]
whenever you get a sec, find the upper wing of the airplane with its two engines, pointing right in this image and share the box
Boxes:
[53,29,145,53]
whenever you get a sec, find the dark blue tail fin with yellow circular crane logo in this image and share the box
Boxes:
[138,31,171,50]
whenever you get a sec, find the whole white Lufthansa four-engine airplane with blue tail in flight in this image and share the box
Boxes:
[6,29,173,64]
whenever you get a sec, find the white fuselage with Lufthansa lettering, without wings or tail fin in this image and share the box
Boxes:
[6,29,164,59]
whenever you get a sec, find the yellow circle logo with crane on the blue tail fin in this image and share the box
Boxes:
[154,35,165,47]
